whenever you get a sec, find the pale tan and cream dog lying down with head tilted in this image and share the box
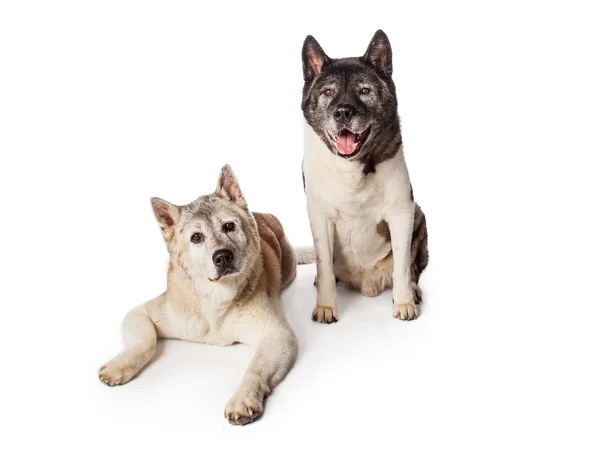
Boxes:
[98,165,314,424]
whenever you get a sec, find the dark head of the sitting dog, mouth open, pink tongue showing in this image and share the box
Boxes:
[302,30,400,167]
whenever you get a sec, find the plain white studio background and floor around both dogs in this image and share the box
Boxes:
[0,1,600,462]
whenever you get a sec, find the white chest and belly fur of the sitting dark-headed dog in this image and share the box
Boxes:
[303,124,410,269]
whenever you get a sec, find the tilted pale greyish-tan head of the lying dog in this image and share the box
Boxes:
[152,165,259,283]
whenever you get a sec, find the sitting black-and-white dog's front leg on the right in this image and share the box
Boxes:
[385,208,417,320]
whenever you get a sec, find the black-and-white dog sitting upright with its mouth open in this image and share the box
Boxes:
[302,30,429,323]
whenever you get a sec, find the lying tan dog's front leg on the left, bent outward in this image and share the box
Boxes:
[98,308,156,386]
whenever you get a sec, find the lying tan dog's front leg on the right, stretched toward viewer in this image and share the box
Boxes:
[225,321,298,424]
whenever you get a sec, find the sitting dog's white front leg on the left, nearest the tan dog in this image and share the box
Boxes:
[308,207,337,323]
